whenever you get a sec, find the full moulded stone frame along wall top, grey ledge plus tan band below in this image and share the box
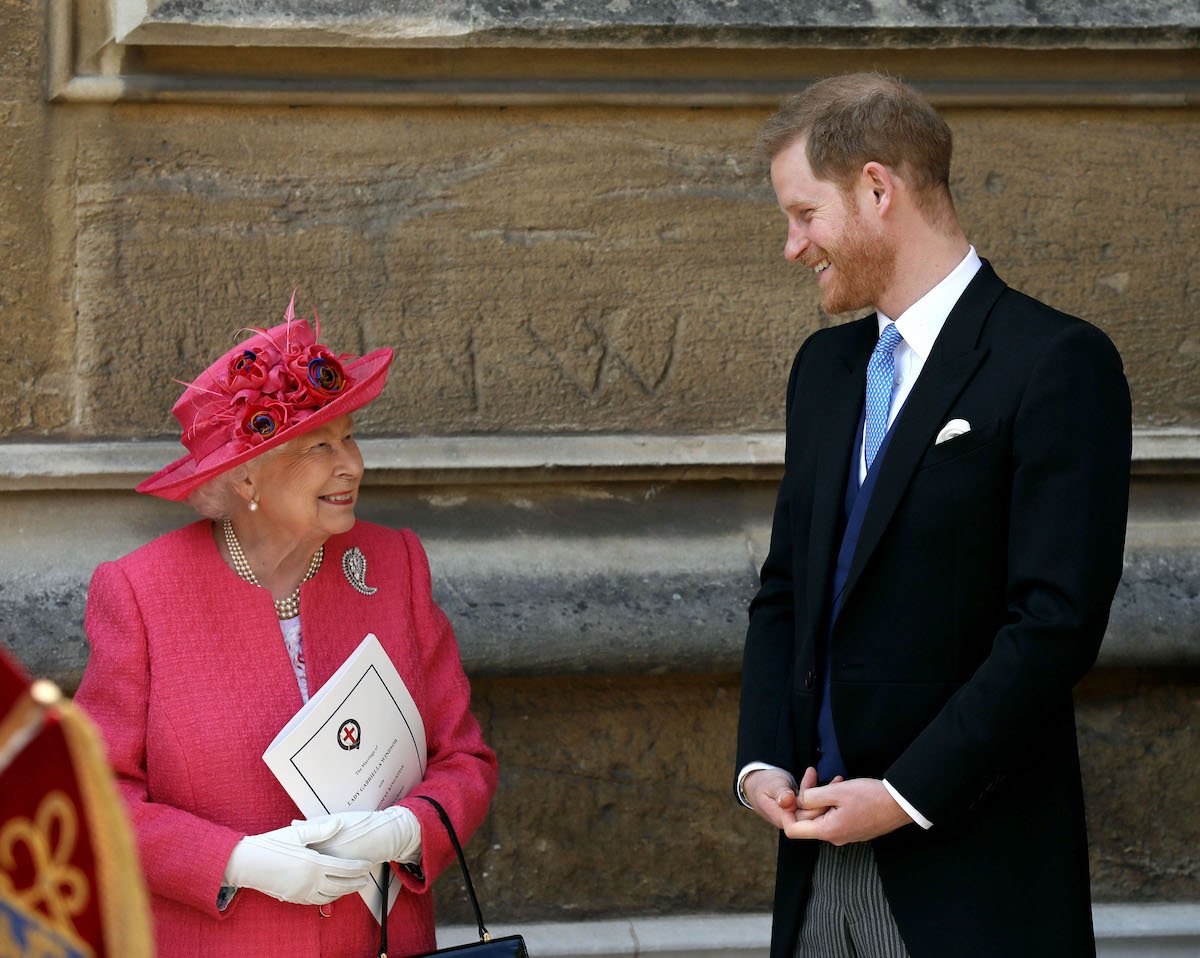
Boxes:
[48,0,1200,109]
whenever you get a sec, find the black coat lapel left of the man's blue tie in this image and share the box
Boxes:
[805,313,878,635]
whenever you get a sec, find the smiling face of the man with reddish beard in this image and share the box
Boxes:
[770,139,896,313]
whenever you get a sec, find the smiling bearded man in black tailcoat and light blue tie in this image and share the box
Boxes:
[737,73,1130,958]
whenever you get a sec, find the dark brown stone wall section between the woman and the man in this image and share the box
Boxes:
[458,676,774,920]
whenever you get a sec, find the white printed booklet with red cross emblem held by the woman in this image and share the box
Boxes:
[263,633,426,921]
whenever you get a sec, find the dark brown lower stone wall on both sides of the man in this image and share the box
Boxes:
[420,670,1200,922]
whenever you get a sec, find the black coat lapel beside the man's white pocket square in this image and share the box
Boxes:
[842,261,1006,606]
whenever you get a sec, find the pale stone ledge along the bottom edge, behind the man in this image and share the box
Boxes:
[438,904,1200,958]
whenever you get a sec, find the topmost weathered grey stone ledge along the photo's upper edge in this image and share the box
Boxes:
[112,0,1200,47]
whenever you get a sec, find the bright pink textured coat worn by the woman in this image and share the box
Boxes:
[76,521,497,958]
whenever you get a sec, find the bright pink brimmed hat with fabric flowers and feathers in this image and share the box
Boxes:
[138,295,392,502]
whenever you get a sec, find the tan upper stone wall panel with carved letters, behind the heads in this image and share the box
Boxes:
[6,107,1200,437]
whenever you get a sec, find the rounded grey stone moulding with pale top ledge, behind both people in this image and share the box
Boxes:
[0,439,1200,688]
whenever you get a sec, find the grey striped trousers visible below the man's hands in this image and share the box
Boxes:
[796,842,908,958]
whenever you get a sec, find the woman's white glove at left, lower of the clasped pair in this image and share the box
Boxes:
[222,825,372,905]
